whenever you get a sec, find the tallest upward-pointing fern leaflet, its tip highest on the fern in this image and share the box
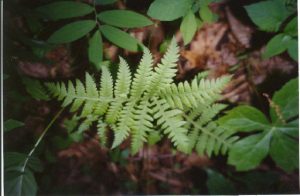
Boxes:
[147,38,179,97]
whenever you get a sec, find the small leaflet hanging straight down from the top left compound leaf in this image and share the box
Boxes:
[88,30,103,70]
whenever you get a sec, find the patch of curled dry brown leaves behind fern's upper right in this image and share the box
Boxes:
[177,7,296,103]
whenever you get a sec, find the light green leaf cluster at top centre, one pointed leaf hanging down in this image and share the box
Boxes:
[148,0,217,45]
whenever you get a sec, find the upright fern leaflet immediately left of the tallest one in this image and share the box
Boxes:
[130,48,153,98]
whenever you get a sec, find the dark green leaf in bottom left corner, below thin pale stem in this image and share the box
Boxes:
[4,170,37,196]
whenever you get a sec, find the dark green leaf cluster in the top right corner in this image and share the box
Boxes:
[245,0,298,61]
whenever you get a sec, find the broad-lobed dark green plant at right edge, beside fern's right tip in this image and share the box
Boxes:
[219,79,299,171]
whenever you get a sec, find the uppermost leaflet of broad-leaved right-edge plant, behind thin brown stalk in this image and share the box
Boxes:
[270,78,299,123]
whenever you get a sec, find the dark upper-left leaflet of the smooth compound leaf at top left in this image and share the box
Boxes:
[36,1,94,20]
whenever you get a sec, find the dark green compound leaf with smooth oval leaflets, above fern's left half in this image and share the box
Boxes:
[35,0,153,69]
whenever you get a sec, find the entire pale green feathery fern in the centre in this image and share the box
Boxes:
[46,40,237,155]
